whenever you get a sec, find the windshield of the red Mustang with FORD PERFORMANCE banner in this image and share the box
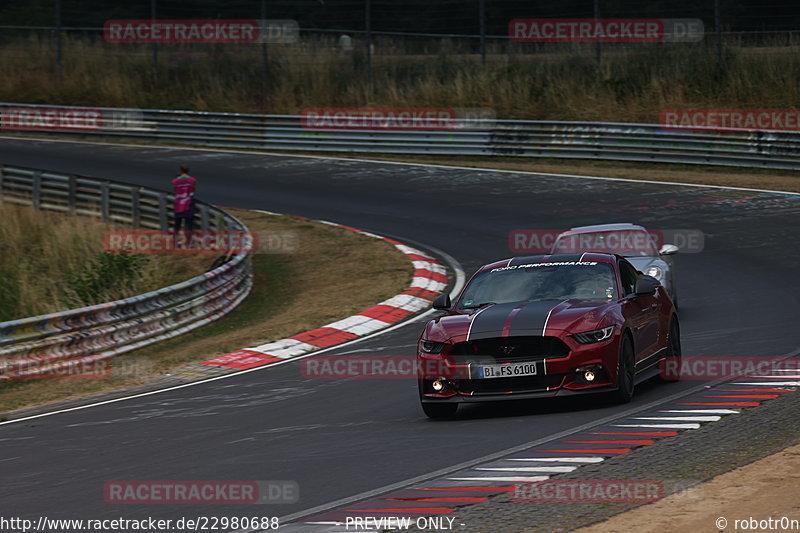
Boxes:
[460,262,617,309]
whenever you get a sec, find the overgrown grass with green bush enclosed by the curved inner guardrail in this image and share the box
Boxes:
[0,203,213,321]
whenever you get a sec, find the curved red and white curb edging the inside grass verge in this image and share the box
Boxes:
[187,211,448,377]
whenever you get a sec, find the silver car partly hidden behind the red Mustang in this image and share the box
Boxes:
[550,223,678,307]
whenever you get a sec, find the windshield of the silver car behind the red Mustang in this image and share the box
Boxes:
[553,230,658,257]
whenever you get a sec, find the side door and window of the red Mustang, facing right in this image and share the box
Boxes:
[619,259,658,363]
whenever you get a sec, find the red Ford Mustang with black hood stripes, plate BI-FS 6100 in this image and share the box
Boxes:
[417,253,681,418]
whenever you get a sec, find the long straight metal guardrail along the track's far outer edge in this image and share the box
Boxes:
[0,103,800,169]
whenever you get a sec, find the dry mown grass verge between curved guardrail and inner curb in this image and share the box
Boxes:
[0,209,412,412]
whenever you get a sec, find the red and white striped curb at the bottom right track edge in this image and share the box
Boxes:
[284,359,800,533]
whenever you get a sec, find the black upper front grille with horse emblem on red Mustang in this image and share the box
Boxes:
[448,336,569,366]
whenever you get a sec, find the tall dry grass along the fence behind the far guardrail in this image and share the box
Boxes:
[0,38,800,122]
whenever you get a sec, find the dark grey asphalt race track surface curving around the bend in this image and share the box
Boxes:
[0,139,800,519]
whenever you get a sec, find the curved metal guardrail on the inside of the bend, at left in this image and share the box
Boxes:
[0,162,252,379]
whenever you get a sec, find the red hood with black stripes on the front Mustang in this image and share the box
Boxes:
[425,300,614,342]
